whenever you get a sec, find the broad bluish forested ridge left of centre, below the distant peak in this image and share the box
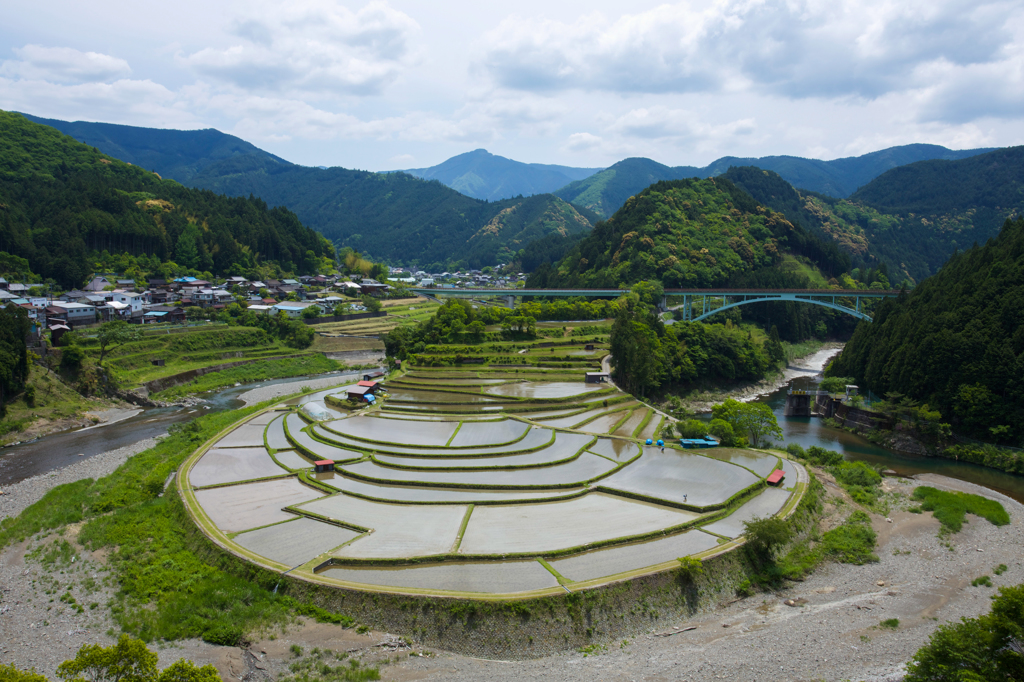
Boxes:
[193,156,592,269]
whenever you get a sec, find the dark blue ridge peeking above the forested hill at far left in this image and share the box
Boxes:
[22,114,292,184]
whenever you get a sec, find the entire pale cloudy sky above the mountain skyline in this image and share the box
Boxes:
[0,0,1024,170]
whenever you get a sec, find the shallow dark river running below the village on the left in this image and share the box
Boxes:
[0,371,374,485]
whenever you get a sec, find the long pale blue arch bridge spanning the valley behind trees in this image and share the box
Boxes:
[410,287,899,322]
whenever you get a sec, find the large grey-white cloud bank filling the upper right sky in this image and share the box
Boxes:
[478,0,1024,98]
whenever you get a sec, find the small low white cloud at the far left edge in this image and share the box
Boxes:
[0,45,131,83]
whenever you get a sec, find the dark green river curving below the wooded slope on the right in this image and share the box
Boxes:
[757,350,1024,503]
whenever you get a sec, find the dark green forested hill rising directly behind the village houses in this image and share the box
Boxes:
[0,112,334,288]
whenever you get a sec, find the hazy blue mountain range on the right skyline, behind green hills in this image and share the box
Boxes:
[554,144,991,217]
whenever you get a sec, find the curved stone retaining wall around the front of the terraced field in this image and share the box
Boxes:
[174,479,818,659]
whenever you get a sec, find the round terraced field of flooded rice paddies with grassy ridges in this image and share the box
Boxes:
[179,368,807,597]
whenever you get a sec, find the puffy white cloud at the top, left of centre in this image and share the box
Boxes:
[180,0,419,94]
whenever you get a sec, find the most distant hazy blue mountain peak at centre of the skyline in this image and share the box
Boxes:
[401,150,601,202]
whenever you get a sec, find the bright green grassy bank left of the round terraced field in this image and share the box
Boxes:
[0,399,360,643]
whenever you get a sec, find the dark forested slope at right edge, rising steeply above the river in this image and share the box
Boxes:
[829,218,1024,445]
